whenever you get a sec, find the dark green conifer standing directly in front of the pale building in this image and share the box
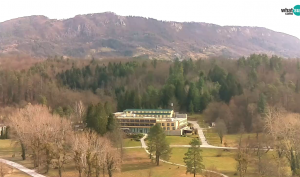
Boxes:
[147,124,171,166]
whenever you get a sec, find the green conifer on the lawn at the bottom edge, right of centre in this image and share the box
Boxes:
[183,138,205,177]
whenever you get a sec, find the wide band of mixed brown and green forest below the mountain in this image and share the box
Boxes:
[0,54,300,133]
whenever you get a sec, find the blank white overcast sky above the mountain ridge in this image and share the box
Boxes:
[0,0,300,39]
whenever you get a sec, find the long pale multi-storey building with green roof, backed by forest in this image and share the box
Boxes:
[115,109,187,135]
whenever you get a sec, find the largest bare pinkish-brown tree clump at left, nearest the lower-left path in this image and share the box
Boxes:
[9,105,72,175]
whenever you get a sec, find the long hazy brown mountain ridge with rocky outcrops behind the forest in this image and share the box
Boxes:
[0,13,300,59]
